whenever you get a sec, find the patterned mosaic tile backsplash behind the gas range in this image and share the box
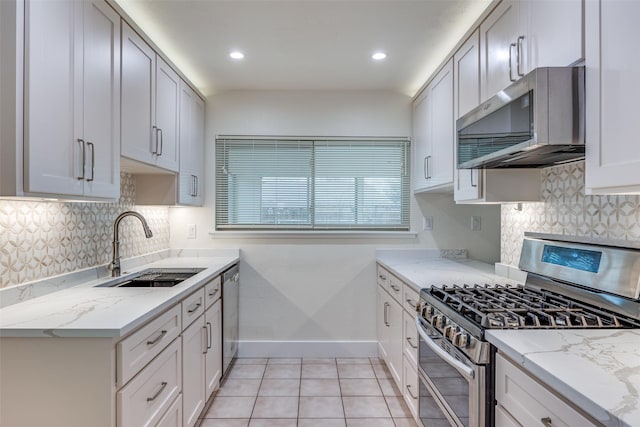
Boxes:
[500,162,640,266]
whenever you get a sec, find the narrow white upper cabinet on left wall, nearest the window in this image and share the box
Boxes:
[178,81,205,206]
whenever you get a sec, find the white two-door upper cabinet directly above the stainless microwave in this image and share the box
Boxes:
[480,0,584,101]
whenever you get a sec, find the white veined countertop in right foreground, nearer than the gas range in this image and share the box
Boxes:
[485,329,640,427]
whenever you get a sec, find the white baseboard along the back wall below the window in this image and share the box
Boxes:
[238,340,378,357]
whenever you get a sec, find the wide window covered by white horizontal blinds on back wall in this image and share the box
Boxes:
[216,136,410,230]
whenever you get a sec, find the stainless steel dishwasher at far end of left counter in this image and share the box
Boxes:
[222,264,240,377]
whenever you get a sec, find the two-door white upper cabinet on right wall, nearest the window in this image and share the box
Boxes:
[413,60,454,192]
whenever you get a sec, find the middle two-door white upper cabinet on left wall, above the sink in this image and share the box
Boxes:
[121,24,180,172]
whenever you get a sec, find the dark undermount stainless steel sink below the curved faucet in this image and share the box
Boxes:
[96,268,204,288]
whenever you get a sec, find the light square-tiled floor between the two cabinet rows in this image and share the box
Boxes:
[200,358,416,427]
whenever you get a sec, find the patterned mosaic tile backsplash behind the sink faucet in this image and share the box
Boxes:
[0,173,169,288]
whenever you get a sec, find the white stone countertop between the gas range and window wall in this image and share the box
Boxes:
[376,249,522,291]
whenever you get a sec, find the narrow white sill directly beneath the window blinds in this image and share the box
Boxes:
[209,230,418,239]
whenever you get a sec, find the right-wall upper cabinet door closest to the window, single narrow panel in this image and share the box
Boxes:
[413,88,432,191]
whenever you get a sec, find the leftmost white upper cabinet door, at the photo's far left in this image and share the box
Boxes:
[24,1,84,195]
